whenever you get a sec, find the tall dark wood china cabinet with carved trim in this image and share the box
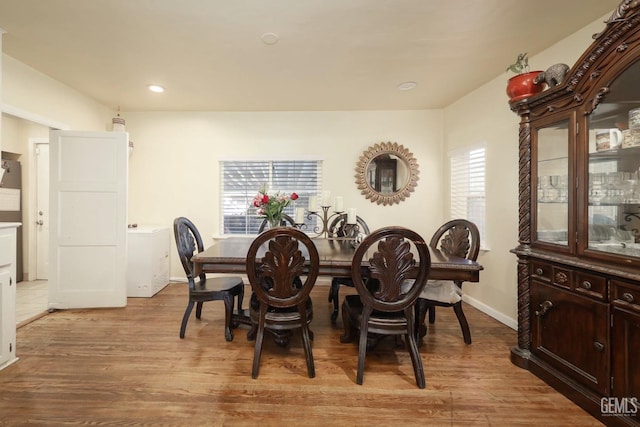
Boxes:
[510,0,640,425]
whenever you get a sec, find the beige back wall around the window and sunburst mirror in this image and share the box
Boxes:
[122,110,442,277]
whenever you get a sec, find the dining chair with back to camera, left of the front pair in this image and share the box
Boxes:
[246,227,320,378]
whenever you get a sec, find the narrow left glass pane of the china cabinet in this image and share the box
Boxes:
[536,120,569,246]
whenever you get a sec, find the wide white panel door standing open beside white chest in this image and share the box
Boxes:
[49,131,128,309]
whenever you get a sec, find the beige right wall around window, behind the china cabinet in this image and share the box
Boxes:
[443,14,610,328]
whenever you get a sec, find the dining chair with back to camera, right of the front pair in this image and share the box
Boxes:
[340,227,431,388]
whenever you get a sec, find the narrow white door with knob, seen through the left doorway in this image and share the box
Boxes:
[35,142,49,280]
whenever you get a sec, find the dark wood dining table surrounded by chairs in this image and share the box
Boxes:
[191,236,483,346]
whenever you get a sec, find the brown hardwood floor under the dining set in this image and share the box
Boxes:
[0,284,602,426]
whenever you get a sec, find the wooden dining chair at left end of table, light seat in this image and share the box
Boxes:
[173,217,244,341]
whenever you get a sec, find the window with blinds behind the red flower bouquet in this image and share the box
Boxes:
[220,160,322,234]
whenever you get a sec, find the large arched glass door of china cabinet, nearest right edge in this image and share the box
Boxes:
[587,60,640,258]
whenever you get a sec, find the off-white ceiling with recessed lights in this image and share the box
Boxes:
[0,0,619,111]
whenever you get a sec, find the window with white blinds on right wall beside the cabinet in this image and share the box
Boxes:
[450,147,485,246]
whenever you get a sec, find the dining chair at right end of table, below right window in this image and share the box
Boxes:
[416,219,480,344]
